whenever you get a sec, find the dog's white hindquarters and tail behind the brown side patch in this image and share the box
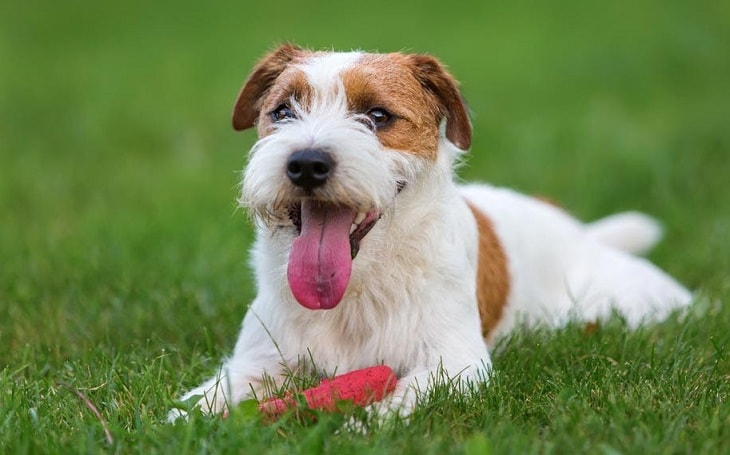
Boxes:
[461,184,692,341]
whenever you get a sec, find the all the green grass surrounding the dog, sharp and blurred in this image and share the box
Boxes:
[0,0,730,454]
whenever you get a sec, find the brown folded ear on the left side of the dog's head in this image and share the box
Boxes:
[233,44,304,131]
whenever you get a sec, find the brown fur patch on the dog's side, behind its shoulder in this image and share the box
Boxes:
[467,201,509,341]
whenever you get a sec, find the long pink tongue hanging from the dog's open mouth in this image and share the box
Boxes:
[287,201,355,310]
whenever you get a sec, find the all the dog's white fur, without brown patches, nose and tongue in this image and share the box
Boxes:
[172,53,691,417]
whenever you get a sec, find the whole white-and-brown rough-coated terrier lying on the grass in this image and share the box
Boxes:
[171,45,692,419]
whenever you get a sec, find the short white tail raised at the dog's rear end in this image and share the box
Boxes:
[586,212,663,255]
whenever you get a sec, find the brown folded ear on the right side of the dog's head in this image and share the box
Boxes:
[409,55,471,150]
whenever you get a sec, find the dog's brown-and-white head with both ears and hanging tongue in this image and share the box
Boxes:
[233,45,471,309]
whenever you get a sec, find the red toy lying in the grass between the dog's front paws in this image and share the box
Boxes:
[259,365,397,418]
